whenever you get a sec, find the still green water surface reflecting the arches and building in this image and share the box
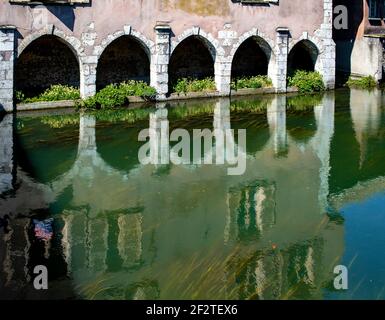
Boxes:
[0,90,385,299]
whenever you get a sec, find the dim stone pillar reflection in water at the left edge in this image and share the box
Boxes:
[0,114,14,194]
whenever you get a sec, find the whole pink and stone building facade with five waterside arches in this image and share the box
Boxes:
[0,0,336,111]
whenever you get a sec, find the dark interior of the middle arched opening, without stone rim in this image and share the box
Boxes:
[169,36,215,92]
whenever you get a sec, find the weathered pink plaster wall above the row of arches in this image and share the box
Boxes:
[0,0,323,44]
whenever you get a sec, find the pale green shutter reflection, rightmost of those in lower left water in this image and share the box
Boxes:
[118,213,143,268]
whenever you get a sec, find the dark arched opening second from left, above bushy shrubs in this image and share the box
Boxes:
[96,36,150,90]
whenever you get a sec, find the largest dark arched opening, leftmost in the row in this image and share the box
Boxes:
[15,35,80,97]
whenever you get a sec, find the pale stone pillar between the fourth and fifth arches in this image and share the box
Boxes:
[272,28,289,92]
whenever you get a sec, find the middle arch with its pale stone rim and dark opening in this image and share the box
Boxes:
[169,27,219,91]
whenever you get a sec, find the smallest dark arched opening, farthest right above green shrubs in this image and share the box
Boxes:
[287,40,318,76]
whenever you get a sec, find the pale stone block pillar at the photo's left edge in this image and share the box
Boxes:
[0,26,16,112]
